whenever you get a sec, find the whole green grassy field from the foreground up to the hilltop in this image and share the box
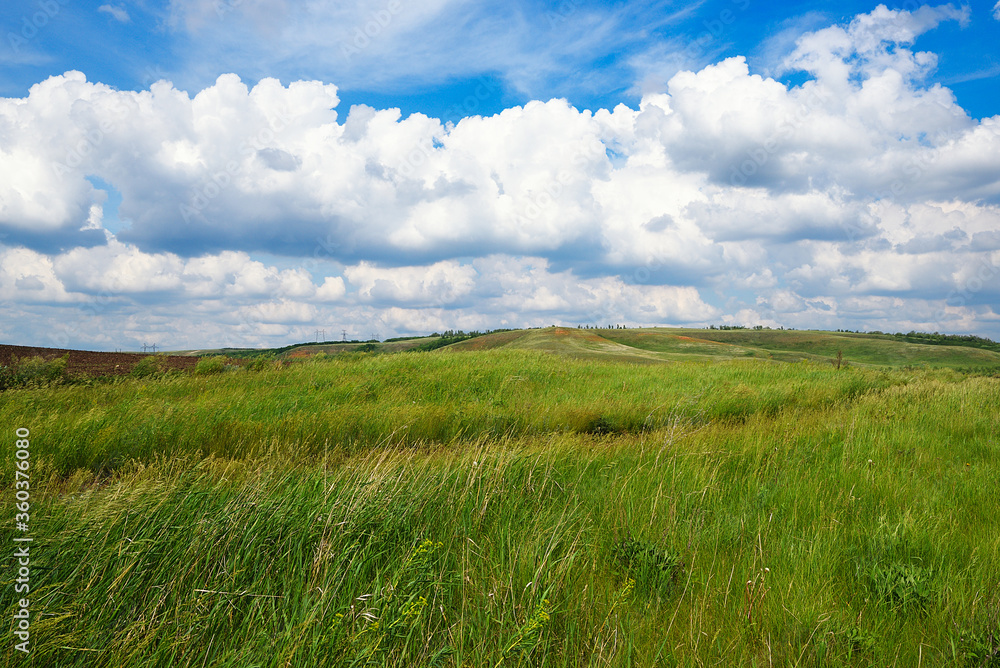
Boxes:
[0,329,1000,667]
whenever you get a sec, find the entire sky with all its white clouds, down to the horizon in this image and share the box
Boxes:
[0,0,1000,349]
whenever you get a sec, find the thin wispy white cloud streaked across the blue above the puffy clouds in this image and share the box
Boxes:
[165,0,700,102]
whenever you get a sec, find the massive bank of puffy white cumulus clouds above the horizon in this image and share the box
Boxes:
[0,5,1000,345]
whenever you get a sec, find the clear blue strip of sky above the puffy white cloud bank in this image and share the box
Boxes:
[7,0,1000,118]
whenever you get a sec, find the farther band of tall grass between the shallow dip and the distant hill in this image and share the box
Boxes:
[0,351,908,476]
